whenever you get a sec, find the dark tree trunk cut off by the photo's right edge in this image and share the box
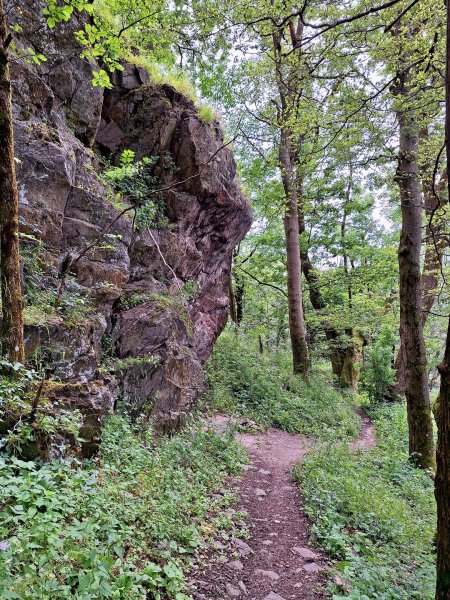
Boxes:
[435,2,450,600]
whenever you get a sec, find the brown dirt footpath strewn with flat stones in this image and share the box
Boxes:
[192,411,375,600]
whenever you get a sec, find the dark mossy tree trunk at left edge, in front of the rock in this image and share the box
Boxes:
[0,0,24,362]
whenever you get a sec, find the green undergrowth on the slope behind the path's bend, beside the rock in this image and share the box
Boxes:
[208,330,360,440]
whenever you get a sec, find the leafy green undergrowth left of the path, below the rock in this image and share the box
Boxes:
[0,415,245,600]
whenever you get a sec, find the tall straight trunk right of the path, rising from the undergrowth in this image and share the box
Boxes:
[393,64,435,468]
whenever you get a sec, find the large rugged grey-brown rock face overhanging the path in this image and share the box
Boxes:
[6,0,251,439]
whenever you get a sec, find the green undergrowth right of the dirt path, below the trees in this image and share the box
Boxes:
[295,404,435,600]
